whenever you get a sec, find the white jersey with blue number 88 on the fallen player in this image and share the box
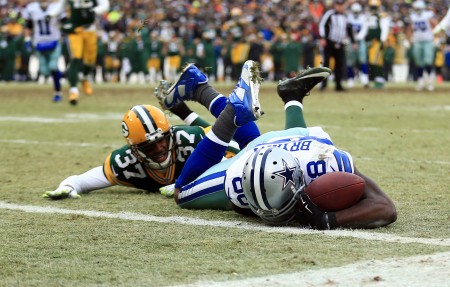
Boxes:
[225,127,354,208]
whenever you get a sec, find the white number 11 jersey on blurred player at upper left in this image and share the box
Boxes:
[24,2,63,47]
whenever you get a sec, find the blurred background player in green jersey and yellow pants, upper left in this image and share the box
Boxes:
[59,0,110,105]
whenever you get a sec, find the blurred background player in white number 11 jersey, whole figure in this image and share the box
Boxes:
[23,1,64,102]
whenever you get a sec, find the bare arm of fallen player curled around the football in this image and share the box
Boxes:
[330,167,397,228]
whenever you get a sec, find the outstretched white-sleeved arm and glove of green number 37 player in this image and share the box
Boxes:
[42,166,113,199]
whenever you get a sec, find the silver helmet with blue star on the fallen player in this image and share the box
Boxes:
[242,147,305,225]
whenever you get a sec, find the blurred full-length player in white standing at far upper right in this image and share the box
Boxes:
[408,0,437,91]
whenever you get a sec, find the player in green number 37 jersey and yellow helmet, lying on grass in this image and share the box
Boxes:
[43,65,243,199]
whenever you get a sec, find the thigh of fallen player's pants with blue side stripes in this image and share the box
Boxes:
[175,159,233,210]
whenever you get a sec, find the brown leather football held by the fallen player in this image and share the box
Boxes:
[305,172,366,211]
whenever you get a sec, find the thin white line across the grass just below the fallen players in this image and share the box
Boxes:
[0,201,450,246]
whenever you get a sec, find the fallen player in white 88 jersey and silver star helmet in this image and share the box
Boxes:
[166,61,397,229]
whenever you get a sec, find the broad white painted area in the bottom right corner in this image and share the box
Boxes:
[173,252,450,287]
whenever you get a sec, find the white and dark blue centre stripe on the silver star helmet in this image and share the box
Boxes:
[250,148,272,210]
